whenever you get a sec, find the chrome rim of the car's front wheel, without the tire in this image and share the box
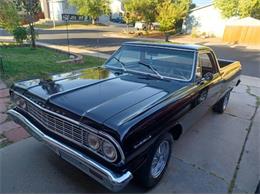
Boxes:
[151,140,170,178]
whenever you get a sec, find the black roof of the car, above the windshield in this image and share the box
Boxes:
[122,41,211,51]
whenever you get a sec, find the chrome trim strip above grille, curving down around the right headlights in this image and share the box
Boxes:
[11,90,125,163]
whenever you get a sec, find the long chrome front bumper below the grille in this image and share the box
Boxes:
[7,109,133,192]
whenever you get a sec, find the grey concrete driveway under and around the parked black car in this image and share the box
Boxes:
[0,76,260,193]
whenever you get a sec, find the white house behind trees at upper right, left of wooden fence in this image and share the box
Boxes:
[182,3,237,37]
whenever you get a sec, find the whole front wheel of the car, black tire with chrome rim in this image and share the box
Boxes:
[135,133,173,188]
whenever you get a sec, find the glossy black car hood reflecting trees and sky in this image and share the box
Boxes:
[16,67,187,131]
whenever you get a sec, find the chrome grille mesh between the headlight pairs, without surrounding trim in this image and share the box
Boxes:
[27,102,88,147]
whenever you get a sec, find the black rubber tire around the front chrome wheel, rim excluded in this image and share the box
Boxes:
[135,133,173,188]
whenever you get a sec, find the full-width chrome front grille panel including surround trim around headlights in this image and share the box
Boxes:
[11,91,125,162]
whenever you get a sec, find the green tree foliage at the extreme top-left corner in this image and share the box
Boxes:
[0,0,20,33]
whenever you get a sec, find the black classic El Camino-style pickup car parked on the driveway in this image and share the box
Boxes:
[8,42,241,191]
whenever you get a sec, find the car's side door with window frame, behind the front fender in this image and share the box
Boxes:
[179,50,222,131]
